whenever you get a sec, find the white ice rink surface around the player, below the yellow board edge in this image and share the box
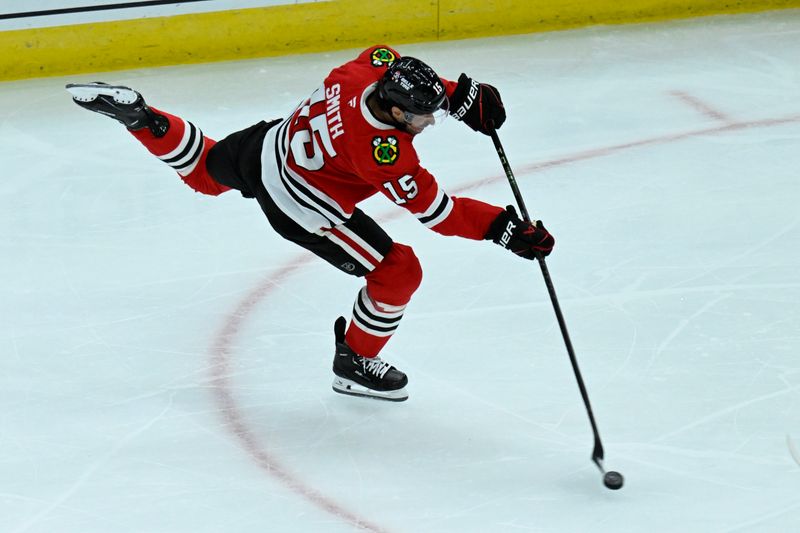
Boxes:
[0,11,800,533]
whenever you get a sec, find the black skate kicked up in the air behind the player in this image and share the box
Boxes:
[67,81,169,137]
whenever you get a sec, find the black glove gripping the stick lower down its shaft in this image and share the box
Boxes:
[484,205,556,259]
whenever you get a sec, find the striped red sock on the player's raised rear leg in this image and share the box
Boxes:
[126,107,231,196]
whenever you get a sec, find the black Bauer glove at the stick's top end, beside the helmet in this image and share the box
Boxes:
[450,74,506,135]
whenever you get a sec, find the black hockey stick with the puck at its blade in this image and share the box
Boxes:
[490,128,622,489]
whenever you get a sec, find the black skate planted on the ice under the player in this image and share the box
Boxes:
[333,317,408,402]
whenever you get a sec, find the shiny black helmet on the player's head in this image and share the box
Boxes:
[378,56,447,115]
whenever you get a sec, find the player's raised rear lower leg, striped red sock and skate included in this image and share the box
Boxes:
[67,82,231,196]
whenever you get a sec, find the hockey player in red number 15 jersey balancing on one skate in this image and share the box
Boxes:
[67,46,554,401]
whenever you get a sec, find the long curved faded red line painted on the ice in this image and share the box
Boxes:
[210,111,800,532]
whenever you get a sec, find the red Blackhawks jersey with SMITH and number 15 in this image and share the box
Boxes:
[261,46,502,239]
